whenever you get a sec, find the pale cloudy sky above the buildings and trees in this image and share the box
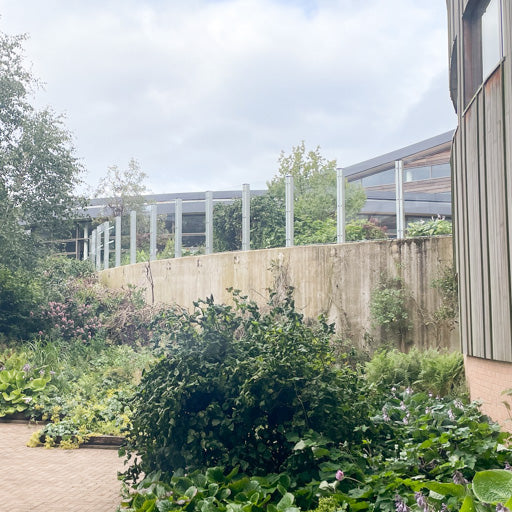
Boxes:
[0,0,456,193]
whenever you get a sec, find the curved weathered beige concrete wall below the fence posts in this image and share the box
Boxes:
[102,236,459,349]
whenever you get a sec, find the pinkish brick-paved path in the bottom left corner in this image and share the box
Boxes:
[0,423,123,512]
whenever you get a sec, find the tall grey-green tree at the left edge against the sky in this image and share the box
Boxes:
[0,33,82,264]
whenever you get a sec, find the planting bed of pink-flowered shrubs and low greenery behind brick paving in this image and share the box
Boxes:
[0,258,162,447]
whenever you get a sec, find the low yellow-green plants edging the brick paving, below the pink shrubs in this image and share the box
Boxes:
[0,340,155,447]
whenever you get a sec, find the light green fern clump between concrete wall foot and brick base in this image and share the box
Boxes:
[365,348,465,397]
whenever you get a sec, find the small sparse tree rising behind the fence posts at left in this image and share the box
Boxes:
[94,158,148,217]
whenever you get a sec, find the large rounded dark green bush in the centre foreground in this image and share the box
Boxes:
[122,295,365,479]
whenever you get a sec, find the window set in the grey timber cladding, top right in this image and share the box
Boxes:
[464,0,503,105]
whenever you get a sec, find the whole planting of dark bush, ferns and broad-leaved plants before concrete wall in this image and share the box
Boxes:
[121,295,512,512]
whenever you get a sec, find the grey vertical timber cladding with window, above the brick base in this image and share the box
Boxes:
[447,0,512,362]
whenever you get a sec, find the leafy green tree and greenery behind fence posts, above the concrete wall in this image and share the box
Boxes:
[214,141,366,251]
